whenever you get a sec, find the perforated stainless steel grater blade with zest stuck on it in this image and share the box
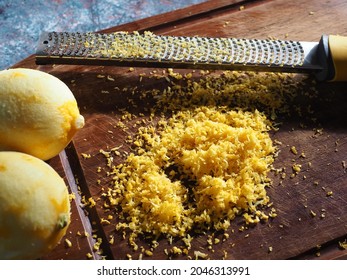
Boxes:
[36,32,347,80]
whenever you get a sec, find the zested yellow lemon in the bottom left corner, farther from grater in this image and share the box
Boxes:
[0,151,70,259]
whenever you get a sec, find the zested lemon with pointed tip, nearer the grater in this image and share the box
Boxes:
[0,68,84,160]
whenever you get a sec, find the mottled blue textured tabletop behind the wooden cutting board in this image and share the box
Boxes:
[0,0,204,70]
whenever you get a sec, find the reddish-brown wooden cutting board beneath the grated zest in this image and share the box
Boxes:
[13,0,347,259]
